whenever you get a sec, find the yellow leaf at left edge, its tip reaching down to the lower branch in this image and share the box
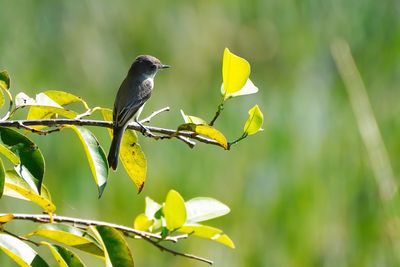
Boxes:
[4,171,56,212]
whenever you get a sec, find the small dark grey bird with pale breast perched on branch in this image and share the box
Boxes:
[107,55,170,170]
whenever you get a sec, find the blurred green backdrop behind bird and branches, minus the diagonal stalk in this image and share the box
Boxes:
[0,0,400,266]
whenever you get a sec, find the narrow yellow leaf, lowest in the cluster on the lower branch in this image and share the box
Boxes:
[178,224,235,248]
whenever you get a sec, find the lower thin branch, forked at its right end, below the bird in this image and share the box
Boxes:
[0,213,213,264]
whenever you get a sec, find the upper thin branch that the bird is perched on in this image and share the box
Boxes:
[0,119,222,150]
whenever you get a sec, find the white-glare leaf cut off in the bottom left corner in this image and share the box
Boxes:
[0,233,48,267]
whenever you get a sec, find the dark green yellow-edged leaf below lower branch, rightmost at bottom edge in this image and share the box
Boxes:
[90,225,134,267]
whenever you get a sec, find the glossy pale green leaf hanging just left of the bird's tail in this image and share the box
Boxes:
[67,125,108,197]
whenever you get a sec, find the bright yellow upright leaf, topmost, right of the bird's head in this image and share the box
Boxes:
[222,48,250,99]
